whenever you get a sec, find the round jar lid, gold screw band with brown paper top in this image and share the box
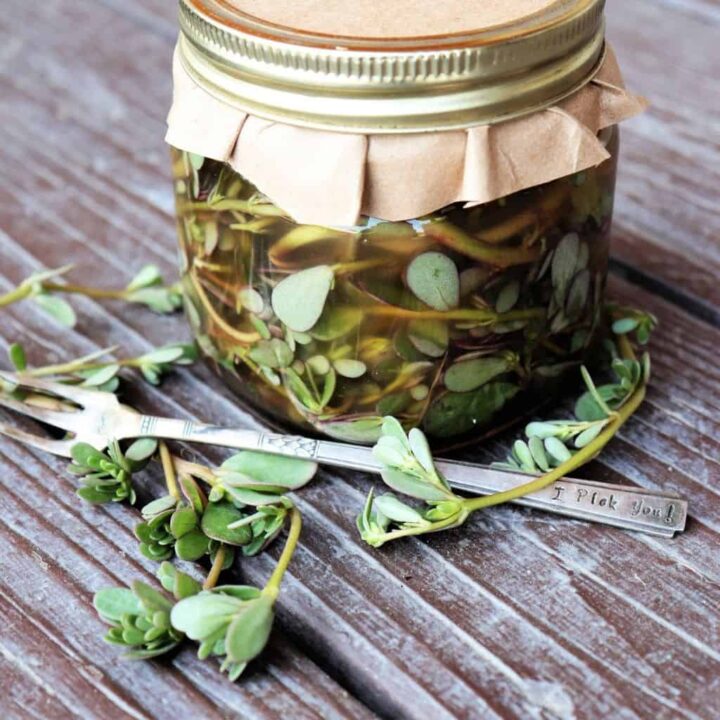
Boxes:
[179,0,604,133]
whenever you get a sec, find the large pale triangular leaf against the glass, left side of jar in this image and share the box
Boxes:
[272,265,335,332]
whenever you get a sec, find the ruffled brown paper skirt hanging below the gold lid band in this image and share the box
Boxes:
[165,48,647,226]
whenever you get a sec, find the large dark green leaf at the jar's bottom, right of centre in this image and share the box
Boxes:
[423,382,519,437]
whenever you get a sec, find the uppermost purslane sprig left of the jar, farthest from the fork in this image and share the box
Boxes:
[0,265,182,327]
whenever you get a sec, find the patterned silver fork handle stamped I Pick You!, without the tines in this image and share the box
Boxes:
[128,416,687,537]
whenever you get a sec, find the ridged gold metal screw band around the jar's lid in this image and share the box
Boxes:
[179,0,605,133]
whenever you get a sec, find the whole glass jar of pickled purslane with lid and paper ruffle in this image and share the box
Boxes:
[167,0,643,447]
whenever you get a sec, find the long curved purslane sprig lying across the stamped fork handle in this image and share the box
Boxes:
[357,314,650,547]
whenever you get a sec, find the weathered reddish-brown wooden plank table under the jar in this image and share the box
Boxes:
[0,0,720,720]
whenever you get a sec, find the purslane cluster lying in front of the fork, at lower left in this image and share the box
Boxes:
[77,440,317,680]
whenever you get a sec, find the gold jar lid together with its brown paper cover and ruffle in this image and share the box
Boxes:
[166,0,645,226]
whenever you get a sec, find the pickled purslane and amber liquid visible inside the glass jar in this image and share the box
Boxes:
[172,129,617,446]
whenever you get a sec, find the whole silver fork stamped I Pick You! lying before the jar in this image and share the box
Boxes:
[0,372,687,537]
